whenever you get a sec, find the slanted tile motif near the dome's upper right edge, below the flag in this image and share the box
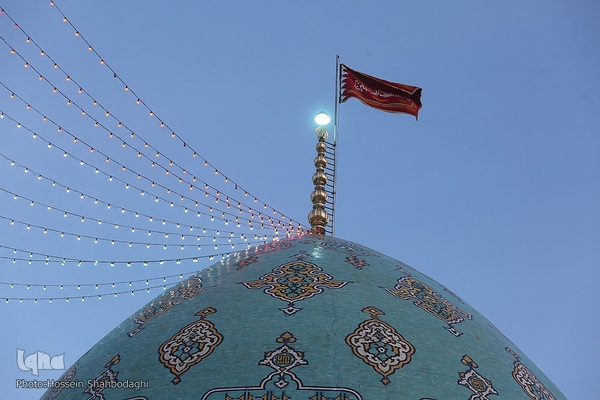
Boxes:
[384,269,473,336]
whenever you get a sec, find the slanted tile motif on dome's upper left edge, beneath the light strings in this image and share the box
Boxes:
[127,275,206,337]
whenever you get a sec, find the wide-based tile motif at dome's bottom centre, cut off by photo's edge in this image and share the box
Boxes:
[201,332,363,400]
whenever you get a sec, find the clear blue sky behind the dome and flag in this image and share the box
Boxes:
[0,0,600,399]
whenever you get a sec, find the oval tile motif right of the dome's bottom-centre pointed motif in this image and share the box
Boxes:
[346,307,415,385]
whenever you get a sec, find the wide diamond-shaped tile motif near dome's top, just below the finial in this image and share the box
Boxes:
[242,260,348,315]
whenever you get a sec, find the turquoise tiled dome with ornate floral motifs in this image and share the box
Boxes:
[43,235,565,400]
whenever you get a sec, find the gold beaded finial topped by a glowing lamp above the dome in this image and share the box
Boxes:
[308,112,331,235]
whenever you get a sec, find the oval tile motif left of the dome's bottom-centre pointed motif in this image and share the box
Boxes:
[158,307,223,385]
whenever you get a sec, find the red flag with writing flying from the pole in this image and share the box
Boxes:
[339,64,422,119]
